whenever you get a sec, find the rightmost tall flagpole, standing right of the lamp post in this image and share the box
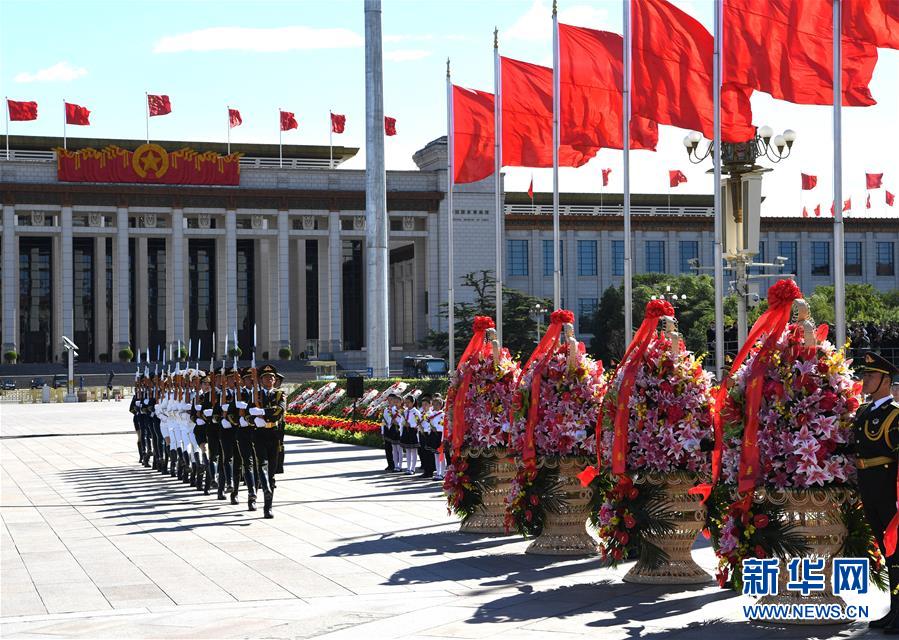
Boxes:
[833,0,846,347]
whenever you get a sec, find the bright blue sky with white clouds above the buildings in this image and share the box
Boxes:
[0,0,899,215]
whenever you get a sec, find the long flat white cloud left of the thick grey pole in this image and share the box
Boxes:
[153,26,365,53]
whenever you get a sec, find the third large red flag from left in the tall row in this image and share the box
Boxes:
[559,24,659,151]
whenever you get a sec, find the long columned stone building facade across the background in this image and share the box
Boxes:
[0,137,899,368]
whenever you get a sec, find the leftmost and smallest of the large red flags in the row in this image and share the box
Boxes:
[453,85,496,184]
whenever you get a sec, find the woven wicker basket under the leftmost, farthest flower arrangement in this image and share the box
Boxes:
[459,447,516,535]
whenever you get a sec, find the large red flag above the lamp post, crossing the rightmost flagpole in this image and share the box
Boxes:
[721,0,877,107]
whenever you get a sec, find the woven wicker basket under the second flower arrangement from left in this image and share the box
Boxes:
[525,456,599,556]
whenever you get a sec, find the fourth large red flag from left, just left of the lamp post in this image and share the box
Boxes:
[631,0,755,142]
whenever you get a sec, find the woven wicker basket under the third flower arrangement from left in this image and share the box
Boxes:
[624,471,712,584]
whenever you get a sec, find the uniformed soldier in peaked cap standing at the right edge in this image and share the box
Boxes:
[853,353,899,635]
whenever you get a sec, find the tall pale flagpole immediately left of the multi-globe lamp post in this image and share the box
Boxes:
[712,2,724,380]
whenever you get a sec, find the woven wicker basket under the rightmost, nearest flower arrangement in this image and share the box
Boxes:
[758,487,851,624]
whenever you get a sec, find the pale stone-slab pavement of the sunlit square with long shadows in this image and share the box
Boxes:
[0,402,887,640]
